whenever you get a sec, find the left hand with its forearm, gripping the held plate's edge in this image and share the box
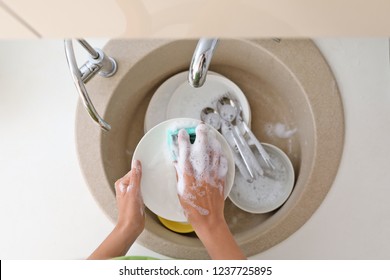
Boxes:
[88,161,145,260]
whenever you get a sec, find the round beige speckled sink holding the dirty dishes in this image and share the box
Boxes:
[76,39,344,259]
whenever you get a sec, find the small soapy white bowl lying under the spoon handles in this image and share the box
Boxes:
[229,143,294,214]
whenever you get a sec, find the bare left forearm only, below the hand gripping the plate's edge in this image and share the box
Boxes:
[88,223,138,260]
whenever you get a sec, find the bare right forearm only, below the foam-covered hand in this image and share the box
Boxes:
[198,222,246,260]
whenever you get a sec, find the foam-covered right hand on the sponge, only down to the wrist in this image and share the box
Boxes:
[175,124,227,233]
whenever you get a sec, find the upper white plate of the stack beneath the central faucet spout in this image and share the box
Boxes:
[166,75,250,124]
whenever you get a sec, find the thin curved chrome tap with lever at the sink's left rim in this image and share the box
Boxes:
[64,39,117,131]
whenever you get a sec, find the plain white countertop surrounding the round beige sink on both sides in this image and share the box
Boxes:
[0,38,390,259]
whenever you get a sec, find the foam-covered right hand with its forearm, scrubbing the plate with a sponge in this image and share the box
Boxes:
[175,124,245,259]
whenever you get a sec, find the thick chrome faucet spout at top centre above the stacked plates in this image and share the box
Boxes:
[188,38,218,88]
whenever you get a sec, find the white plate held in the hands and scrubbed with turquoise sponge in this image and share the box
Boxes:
[133,118,235,222]
